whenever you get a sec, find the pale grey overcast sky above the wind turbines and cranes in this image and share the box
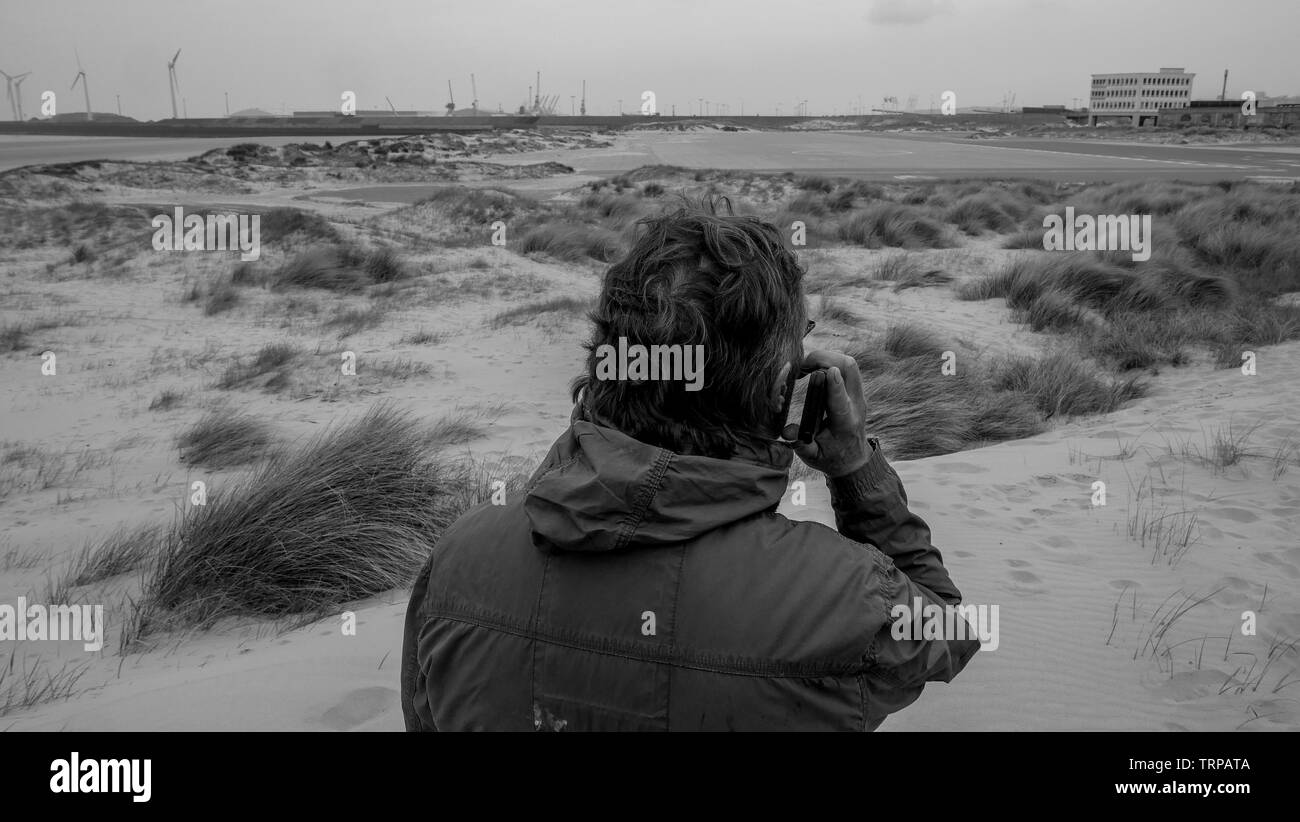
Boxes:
[0,0,1300,120]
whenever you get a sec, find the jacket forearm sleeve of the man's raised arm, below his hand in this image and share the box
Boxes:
[827,440,962,605]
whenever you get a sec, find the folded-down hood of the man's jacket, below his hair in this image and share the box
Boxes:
[524,410,794,551]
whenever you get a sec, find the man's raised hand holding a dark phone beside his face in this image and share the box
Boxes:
[783,350,871,477]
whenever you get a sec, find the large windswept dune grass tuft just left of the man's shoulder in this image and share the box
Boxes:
[124,404,496,646]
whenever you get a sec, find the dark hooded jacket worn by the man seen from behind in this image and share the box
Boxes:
[402,408,979,731]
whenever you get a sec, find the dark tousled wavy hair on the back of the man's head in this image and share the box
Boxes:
[573,198,807,459]
